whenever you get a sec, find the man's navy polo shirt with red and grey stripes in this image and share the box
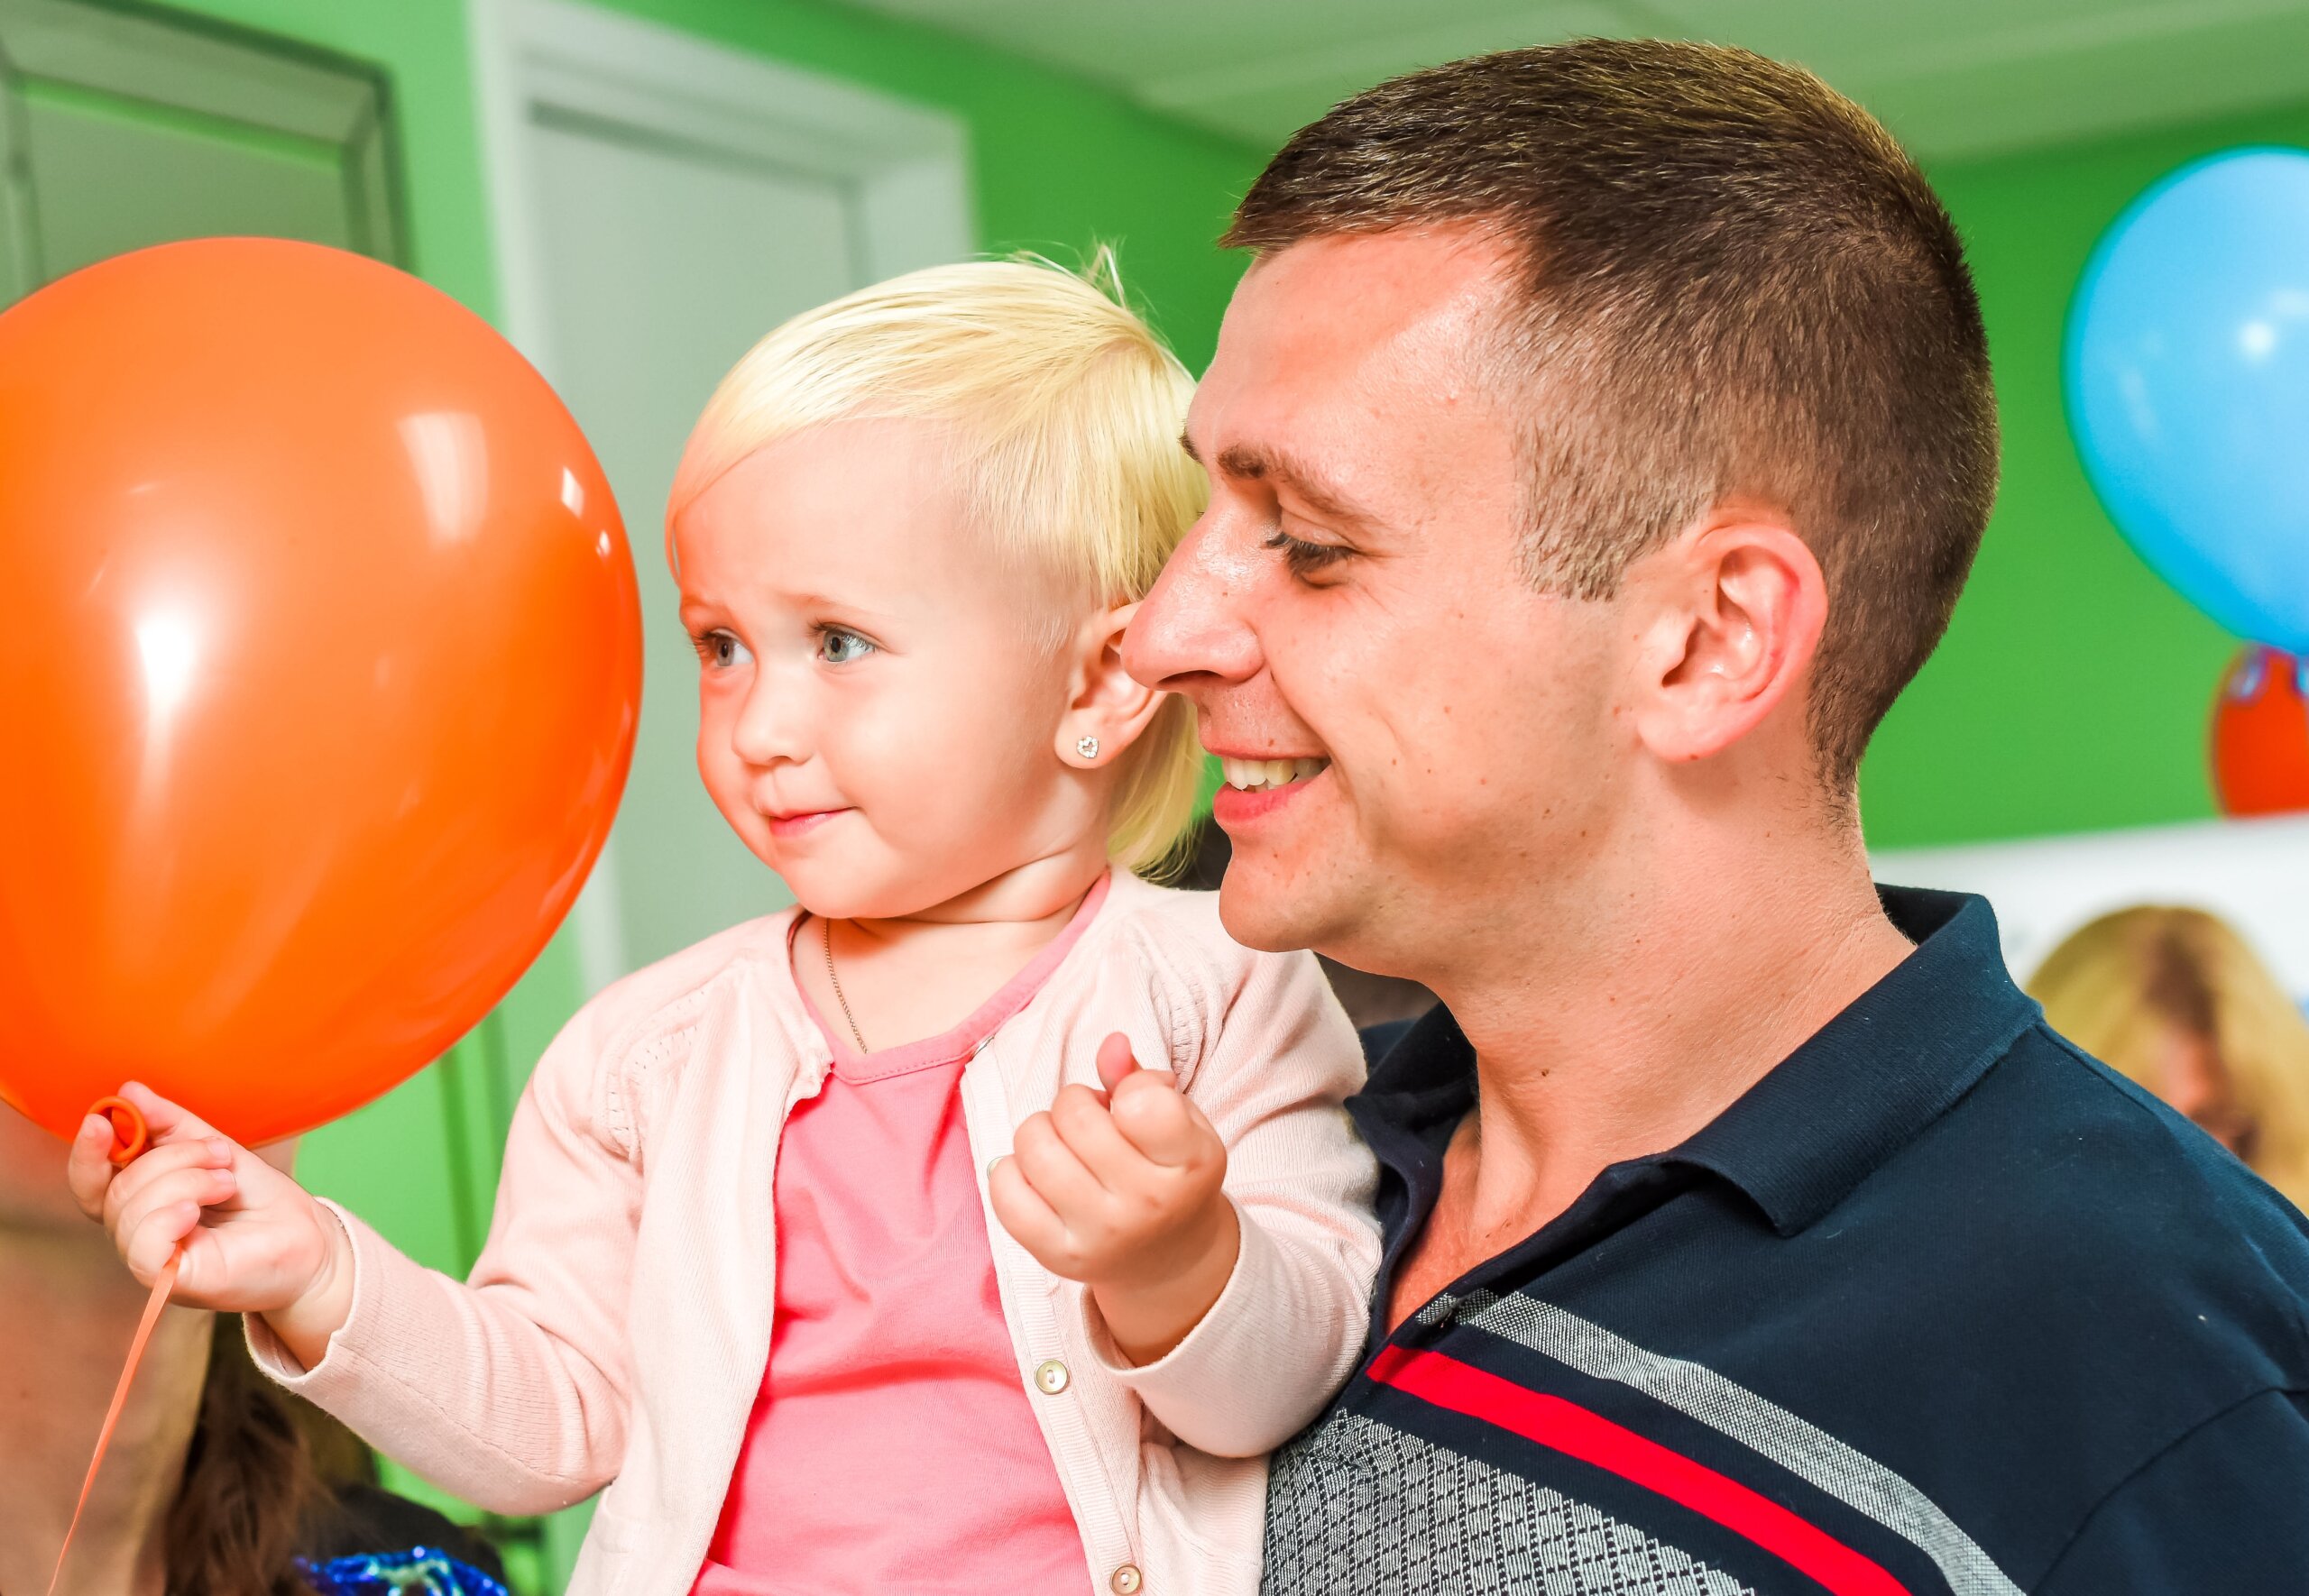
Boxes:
[1263,889,2309,1596]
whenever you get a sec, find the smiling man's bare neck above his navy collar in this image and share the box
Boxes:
[1436,803,1909,1234]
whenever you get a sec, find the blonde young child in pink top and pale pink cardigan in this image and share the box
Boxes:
[74,263,1376,1596]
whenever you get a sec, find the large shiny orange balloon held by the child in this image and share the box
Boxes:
[0,238,642,1143]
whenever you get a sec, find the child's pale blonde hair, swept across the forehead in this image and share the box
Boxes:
[665,250,1208,873]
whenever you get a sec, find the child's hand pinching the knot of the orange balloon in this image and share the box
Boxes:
[65,1086,354,1367]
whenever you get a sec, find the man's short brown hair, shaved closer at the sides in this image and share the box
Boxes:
[1224,40,1997,793]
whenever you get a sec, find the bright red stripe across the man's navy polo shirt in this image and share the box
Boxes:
[1372,1346,1909,1596]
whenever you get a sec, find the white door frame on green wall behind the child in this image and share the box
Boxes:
[469,0,977,993]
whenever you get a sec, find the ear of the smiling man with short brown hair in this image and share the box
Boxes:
[1628,509,1829,762]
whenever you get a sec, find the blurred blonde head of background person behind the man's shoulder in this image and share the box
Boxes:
[2028,905,2309,1208]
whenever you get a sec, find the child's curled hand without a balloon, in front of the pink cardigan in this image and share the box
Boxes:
[989,1035,1242,1362]
